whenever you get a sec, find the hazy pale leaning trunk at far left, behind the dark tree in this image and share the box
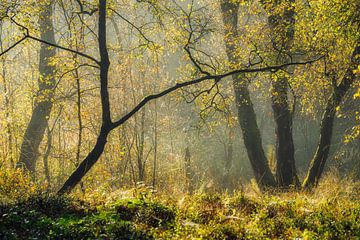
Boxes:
[17,1,56,175]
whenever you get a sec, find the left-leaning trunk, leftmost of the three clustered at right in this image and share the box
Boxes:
[221,0,276,187]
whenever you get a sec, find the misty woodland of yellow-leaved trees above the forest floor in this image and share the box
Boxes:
[0,0,360,206]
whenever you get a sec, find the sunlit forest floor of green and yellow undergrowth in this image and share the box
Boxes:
[0,175,360,239]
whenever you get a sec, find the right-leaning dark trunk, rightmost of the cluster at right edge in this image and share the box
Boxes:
[303,42,360,189]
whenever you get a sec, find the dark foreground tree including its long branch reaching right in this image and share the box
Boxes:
[0,0,324,194]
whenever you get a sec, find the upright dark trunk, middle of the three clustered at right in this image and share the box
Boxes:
[261,0,299,187]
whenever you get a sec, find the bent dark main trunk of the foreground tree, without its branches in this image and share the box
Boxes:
[58,0,112,194]
